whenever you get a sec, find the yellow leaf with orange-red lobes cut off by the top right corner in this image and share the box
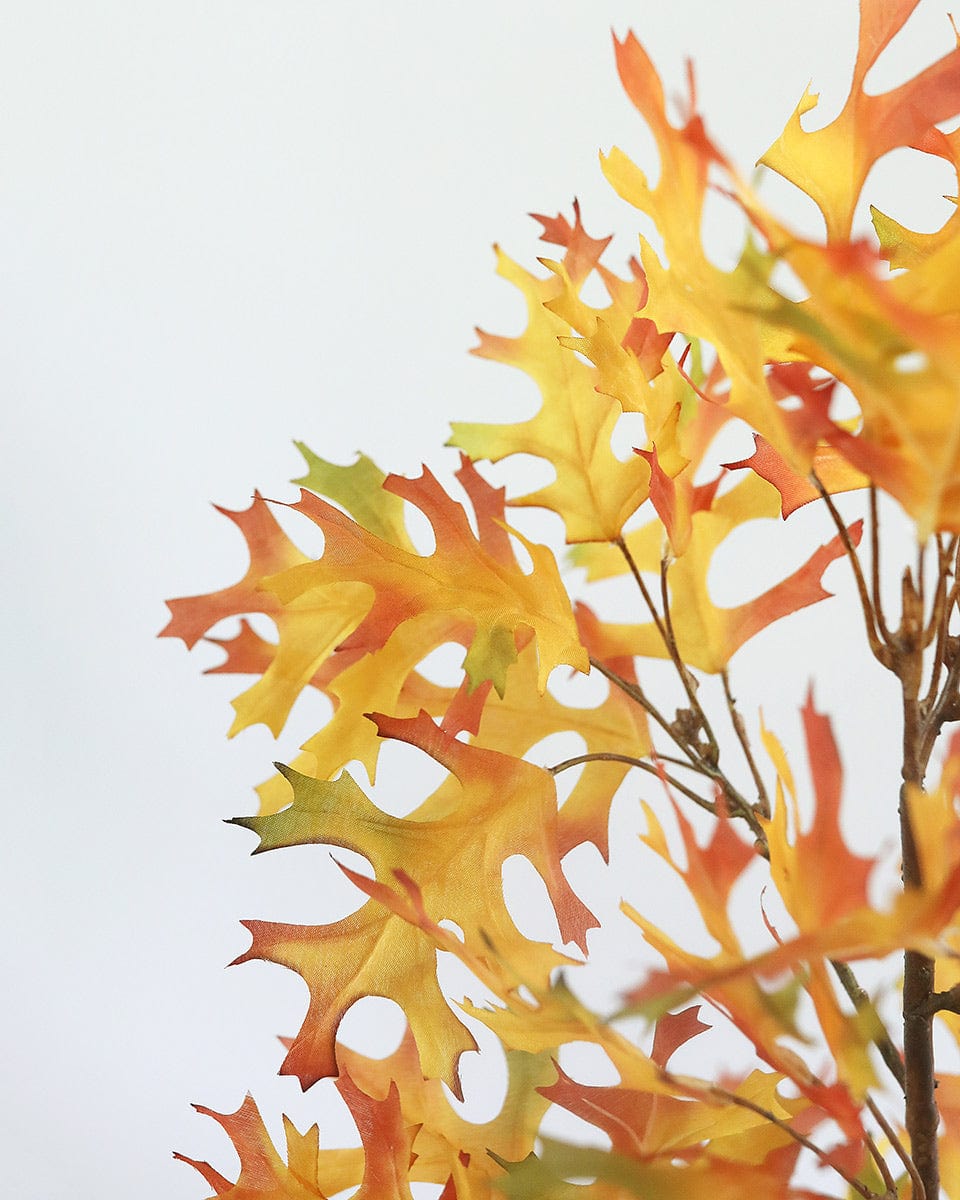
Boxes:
[760,0,960,242]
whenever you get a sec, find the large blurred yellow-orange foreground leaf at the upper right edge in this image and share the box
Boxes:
[764,112,960,539]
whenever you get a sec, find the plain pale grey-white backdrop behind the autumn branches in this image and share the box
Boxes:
[0,0,953,1200]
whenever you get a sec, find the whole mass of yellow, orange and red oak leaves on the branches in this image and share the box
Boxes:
[163,0,960,1200]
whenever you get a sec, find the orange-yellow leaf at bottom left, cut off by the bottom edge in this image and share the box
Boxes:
[174,1096,331,1200]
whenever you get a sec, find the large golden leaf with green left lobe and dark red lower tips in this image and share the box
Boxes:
[234,713,595,1091]
